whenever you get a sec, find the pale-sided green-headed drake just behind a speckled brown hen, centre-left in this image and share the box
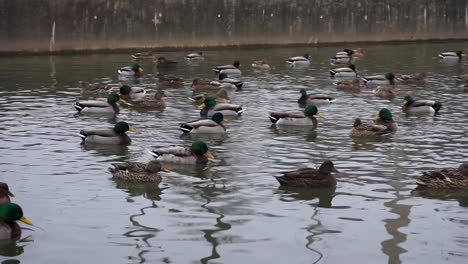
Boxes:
[149,141,214,164]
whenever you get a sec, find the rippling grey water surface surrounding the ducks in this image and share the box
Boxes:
[0,42,468,263]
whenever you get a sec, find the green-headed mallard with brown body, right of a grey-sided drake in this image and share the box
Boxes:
[351,108,398,137]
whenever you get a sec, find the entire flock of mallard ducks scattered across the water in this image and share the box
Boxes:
[0,49,468,239]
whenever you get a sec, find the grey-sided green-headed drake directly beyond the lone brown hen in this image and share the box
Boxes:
[268,105,322,128]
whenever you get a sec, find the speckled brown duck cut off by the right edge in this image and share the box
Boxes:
[416,162,468,189]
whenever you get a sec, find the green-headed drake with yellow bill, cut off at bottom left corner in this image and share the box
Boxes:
[0,202,33,240]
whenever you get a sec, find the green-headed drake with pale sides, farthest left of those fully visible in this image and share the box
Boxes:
[74,93,131,114]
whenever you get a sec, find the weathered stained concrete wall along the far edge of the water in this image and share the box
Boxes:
[0,0,468,53]
